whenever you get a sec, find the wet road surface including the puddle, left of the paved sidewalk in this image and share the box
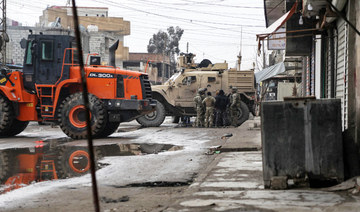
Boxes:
[0,119,235,211]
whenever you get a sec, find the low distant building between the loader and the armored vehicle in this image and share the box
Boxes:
[124,53,174,85]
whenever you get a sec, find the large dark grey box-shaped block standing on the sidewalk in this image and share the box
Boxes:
[261,99,344,188]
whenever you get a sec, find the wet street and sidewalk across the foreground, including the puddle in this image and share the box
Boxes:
[0,118,360,212]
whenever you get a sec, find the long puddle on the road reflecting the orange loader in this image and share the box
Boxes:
[0,139,183,193]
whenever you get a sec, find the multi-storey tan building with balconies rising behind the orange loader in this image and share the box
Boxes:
[37,6,130,67]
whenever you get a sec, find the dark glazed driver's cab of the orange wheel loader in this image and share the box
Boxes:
[23,34,74,92]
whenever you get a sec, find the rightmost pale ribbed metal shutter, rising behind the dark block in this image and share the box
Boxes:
[335,19,348,130]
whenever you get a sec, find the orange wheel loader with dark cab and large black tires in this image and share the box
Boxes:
[0,34,156,139]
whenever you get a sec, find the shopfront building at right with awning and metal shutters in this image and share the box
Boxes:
[258,0,360,179]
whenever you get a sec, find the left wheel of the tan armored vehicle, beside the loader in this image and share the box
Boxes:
[136,101,165,127]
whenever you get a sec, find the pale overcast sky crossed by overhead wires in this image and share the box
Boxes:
[7,0,265,69]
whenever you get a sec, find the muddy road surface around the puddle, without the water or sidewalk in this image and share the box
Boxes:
[0,119,243,211]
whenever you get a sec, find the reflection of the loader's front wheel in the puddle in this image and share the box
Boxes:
[55,146,102,179]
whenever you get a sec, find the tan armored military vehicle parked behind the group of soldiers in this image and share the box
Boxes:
[136,53,255,127]
